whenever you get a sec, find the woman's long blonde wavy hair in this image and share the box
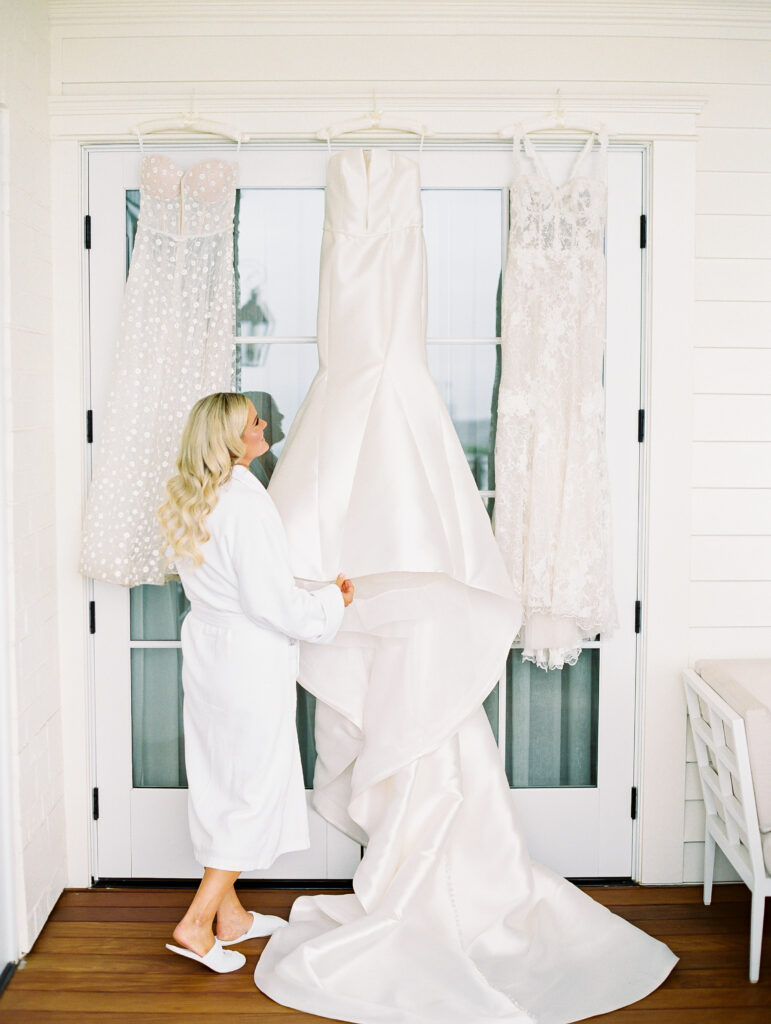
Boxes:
[158,391,249,565]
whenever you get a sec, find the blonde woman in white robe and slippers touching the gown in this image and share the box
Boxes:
[159,393,353,973]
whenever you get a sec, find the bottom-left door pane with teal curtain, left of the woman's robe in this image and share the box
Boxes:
[131,651,187,790]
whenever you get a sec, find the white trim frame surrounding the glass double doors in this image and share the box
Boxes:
[51,103,704,886]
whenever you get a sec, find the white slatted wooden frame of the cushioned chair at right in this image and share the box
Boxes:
[683,669,771,981]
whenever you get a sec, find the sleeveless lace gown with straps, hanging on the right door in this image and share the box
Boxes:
[494,135,617,669]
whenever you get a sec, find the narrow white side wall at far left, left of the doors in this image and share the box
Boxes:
[0,0,67,951]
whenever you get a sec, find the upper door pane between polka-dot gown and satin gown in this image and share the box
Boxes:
[235,188,324,338]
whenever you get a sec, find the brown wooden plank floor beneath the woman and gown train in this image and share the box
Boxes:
[0,886,771,1024]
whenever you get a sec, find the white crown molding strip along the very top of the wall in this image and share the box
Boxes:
[48,0,771,38]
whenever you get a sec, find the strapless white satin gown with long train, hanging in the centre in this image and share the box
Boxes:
[255,150,676,1024]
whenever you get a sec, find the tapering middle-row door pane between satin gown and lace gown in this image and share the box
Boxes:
[427,342,499,490]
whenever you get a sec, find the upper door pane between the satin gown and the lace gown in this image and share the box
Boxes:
[421,188,503,338]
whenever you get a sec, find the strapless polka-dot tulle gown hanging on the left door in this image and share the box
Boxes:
[81,155,235,587]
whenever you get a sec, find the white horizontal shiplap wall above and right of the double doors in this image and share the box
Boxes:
[41,0,771,882]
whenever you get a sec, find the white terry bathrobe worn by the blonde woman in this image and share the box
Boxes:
[177,466,344,871]
